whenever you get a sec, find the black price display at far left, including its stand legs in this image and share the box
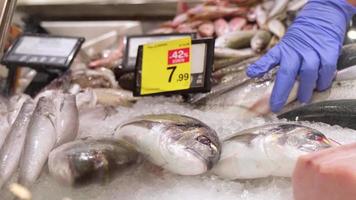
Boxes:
[1,35,84,96]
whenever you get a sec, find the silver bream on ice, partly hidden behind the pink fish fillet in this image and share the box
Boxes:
[212,123,338,180]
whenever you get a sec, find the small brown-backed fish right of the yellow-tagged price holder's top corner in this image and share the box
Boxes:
[215,30,256,49]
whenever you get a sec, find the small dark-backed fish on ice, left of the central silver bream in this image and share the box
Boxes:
[48,139,138,186]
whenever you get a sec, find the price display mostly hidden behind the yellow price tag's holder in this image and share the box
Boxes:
[122,33,196,72]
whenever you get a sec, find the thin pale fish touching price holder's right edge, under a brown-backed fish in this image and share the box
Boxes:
[214,47,256,59]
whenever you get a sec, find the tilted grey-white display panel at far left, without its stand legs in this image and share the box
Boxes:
[1,35,84,71]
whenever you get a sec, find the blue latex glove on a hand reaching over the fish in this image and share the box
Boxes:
[247,0,356,112]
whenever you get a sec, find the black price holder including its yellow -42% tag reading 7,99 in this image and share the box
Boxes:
[134,38,215,96]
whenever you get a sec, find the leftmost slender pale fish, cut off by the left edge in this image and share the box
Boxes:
[0,100,34,188]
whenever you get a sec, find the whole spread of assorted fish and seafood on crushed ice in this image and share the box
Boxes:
[0,0,356,200]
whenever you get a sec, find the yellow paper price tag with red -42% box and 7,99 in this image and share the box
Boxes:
[141,37,192,95]
